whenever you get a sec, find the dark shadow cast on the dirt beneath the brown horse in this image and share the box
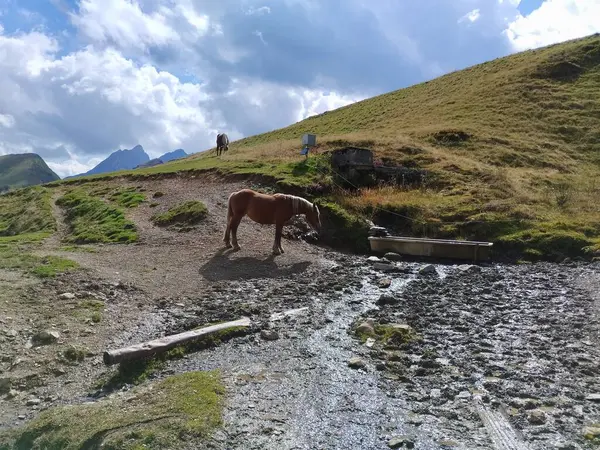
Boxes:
[200,249,311,281]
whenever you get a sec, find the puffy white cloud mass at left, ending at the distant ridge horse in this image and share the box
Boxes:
[0,28,217,174]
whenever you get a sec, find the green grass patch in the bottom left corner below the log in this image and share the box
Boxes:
[0,371,224,450]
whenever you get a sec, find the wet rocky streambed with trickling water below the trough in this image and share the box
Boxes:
[154,256,600,449]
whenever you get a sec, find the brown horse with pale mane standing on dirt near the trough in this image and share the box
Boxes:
[223,189,321,255]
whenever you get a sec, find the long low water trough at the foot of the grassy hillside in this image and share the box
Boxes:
[369,236,494,262]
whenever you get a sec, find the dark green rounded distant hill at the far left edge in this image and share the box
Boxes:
[0,153,60,192]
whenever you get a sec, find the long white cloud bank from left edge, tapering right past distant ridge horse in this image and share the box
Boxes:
[0,20,360,176]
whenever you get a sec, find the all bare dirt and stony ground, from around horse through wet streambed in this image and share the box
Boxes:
[0,180,600,449]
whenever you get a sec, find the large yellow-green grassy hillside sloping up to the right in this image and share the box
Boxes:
[50,35,600,257]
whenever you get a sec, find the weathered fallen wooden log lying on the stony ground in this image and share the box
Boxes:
[103,317,252,366]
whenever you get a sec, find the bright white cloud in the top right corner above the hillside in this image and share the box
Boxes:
[505,0,600,51]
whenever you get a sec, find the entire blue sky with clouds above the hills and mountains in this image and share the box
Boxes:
[0,0,600,176]
